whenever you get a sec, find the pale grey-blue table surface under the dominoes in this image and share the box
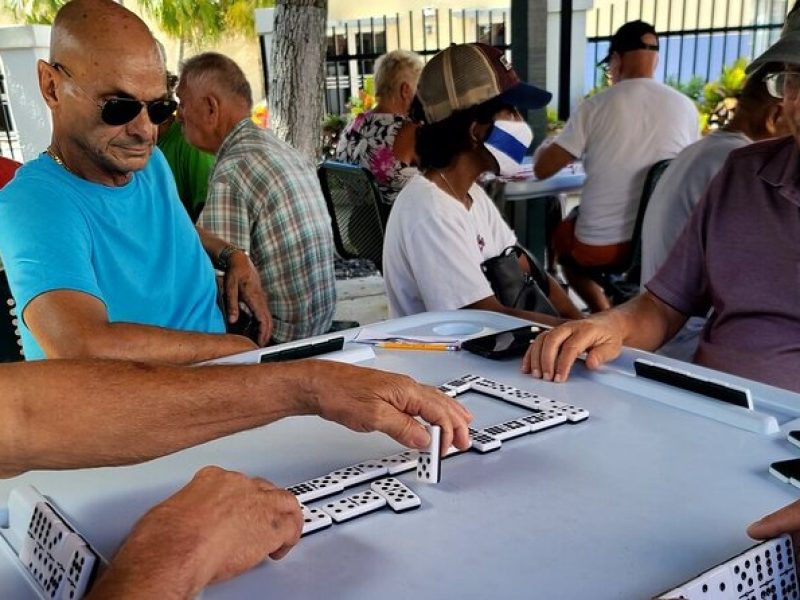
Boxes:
[0,311,800,600]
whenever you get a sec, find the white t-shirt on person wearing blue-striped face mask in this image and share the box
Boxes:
[383,175,517,318]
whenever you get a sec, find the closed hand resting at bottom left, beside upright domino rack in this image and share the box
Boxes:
[93,467,303,598]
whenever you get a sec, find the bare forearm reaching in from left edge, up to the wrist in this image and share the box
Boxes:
[0,361,315,477]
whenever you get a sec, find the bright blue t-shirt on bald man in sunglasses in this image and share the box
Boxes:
[0,149,225,359]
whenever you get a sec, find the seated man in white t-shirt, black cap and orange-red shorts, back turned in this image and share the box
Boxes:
[534,21,699,312]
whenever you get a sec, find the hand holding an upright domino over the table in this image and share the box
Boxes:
[304,361,472,451]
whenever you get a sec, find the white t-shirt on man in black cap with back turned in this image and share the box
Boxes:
[555,78,699,246]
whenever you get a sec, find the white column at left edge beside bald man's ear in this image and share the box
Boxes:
[0,25,52,160]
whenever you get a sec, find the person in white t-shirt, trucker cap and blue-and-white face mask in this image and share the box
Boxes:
[383,44,581,324]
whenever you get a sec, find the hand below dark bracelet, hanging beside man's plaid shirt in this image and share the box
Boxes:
[224,252,272,347]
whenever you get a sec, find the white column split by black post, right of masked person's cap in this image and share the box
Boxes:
[547,0,594,115]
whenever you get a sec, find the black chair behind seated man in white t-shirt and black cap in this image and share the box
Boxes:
[564,158,672,306]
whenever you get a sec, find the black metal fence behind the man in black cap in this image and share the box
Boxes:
[584,0,793,92]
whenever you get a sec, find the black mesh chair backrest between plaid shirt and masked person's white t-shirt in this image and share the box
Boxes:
[317,160,384,270]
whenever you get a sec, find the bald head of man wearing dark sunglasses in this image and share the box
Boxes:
[37,0,172,185]
